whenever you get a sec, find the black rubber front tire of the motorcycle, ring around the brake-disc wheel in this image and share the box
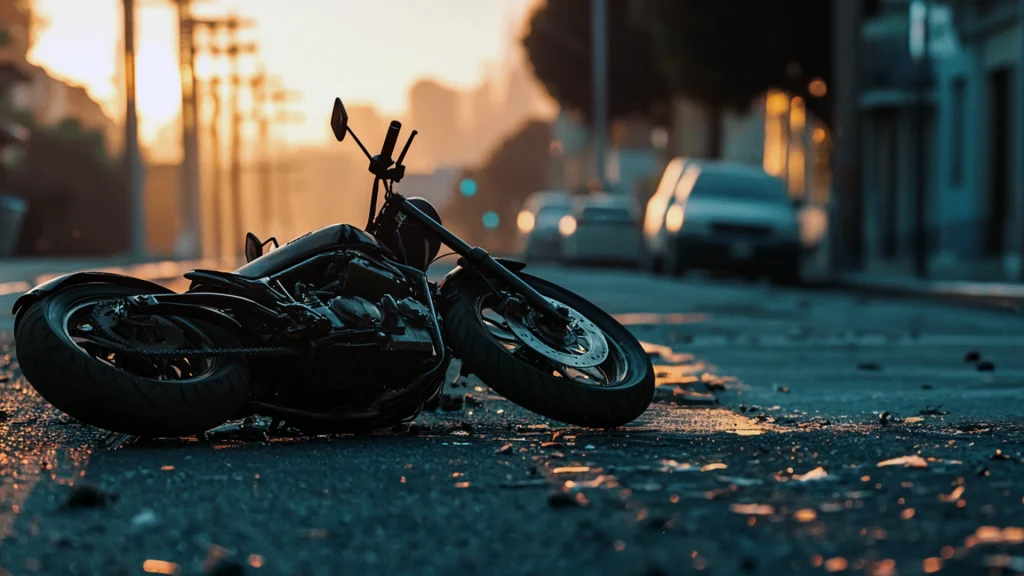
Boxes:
[443,273,654,428]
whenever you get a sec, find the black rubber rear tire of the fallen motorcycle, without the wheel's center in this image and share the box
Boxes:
[14,284,250,438]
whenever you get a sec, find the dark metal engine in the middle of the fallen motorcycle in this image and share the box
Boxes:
[304,252,435,409]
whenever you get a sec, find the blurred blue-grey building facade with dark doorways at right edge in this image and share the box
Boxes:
[838,0,1024,281]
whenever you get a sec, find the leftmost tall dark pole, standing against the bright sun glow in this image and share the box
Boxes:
[124,0,148,258]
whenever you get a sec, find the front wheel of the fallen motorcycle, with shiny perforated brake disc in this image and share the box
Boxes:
[444,273,654,428]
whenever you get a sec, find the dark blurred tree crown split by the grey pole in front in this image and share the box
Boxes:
[522,0,669,119]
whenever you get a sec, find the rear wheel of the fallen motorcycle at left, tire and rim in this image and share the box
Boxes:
[14,284,250,438]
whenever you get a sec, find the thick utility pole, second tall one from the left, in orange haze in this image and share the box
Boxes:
[176,0,203,257]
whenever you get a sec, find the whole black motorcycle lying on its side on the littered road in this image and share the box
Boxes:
[13,98,654,437]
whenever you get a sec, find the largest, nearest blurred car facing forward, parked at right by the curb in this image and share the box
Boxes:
[665,162,802,284]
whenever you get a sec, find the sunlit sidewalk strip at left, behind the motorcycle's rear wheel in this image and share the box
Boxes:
[0,256,239,296]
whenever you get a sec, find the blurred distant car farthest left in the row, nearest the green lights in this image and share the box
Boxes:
[516,192,572,260]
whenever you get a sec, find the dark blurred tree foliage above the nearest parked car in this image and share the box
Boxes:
[632,0,833,154]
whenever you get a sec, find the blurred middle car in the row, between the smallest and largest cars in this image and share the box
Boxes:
[558,195,643,266]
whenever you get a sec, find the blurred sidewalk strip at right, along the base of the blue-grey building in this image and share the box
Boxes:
[834,273,1024,310]
